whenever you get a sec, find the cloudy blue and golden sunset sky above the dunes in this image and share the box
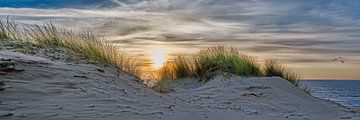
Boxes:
[0,0,360,79]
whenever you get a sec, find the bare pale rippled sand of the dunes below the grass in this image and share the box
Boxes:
[0,51,360,120]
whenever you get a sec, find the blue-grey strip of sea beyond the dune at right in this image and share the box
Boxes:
[300,80,360,108]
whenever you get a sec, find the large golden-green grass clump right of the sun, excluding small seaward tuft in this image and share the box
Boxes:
[162,46,261,82]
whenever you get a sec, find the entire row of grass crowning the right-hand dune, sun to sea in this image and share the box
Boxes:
[158,46,301,86]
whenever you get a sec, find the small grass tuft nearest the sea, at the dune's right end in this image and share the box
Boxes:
[264,59,301,86]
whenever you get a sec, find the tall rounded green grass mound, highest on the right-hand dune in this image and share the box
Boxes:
[194,46,261,82]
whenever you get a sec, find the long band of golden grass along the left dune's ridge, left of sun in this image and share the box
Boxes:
[0,19,139,76]
